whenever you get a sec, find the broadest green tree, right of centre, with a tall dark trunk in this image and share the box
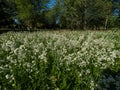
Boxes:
[60,0,113,29]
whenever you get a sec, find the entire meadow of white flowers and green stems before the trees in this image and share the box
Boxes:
[0,31,120,90]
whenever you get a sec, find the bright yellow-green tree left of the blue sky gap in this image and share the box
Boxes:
[15,0,49,29]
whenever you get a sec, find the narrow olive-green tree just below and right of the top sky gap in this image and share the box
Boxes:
[45,0,63,29]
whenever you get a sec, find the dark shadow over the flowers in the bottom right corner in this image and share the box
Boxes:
[96,68,120,90]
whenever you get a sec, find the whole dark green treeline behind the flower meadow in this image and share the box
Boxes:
[0,0,120,30]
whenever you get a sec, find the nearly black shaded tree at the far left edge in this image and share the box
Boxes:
[0,0,14,28]
